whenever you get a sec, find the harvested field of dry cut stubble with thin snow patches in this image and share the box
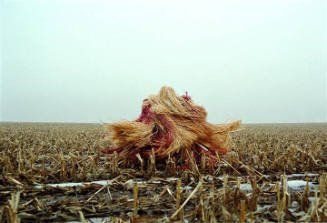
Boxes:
[0,123,327,222]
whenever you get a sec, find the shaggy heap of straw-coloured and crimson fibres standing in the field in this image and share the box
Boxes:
[103,86,241,166]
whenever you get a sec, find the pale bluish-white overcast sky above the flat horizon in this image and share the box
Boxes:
[0,0,327,123]
